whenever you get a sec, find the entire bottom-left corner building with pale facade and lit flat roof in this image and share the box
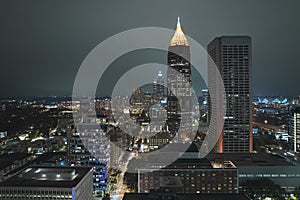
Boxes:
[0,166,93,200]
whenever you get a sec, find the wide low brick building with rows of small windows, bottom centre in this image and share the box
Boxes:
[138,158,238,194]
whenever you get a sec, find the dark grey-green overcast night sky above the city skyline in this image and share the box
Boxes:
[0,0,300,97]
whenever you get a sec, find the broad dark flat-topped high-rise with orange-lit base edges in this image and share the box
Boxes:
[207,36,252,153]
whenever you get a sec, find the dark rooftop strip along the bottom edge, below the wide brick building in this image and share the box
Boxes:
[123,193,249,200]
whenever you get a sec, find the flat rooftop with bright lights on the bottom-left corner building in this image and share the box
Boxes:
[0,166,91,188]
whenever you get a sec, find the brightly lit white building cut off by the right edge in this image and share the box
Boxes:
[289,106,300,152]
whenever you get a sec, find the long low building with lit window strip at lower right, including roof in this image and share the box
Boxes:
[207,153,300,192]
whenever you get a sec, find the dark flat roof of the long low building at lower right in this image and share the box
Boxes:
[206,153,293,167]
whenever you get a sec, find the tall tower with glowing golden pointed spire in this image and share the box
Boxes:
[167,17,192,139]
